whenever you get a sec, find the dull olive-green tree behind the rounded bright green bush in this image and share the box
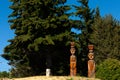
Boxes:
[90,15,120,64]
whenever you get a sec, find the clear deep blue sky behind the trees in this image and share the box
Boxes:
[0,0,120,72]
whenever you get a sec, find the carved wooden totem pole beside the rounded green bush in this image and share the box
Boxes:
[88,45,95,78]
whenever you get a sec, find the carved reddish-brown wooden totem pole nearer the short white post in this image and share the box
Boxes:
[70,42,77,76]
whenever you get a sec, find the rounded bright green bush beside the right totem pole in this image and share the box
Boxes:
[96,58,120,80]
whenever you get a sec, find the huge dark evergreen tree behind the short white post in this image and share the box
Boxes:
[3,0,71,77]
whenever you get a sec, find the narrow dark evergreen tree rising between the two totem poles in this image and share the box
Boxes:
[74,0,94,76]
